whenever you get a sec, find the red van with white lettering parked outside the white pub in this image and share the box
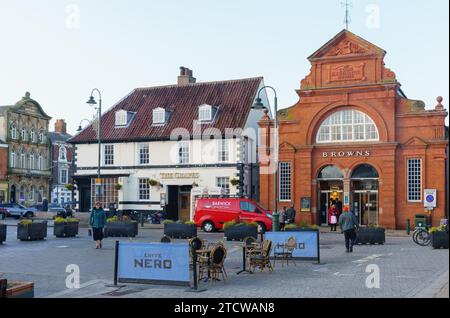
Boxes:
[194,198,272,232]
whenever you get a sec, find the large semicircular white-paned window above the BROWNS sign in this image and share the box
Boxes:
[317,110,380,143]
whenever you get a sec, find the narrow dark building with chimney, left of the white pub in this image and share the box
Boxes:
[49,119,75,205]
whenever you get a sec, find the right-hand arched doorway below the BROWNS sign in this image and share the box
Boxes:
[351,164,380,226]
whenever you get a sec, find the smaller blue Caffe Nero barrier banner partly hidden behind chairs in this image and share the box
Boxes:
[266,230,320,263]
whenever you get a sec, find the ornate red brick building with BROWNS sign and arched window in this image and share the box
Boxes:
[260,30,448,228]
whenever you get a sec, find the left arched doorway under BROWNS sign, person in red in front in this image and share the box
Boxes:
[317,165,344,225]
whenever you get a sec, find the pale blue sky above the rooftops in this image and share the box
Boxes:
[0,0,450,133]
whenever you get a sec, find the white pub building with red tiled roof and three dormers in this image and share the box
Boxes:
[70,68,267,220]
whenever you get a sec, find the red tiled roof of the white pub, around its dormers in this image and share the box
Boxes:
[69,77,263,144]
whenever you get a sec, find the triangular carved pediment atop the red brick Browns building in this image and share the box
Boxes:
[308,30,386,61]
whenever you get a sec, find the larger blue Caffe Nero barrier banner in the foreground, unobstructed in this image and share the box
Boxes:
[117,242,190,286]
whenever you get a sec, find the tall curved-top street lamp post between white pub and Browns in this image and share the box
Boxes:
[253,86,279,232]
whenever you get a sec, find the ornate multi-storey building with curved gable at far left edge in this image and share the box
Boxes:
[0,93,51,206]
